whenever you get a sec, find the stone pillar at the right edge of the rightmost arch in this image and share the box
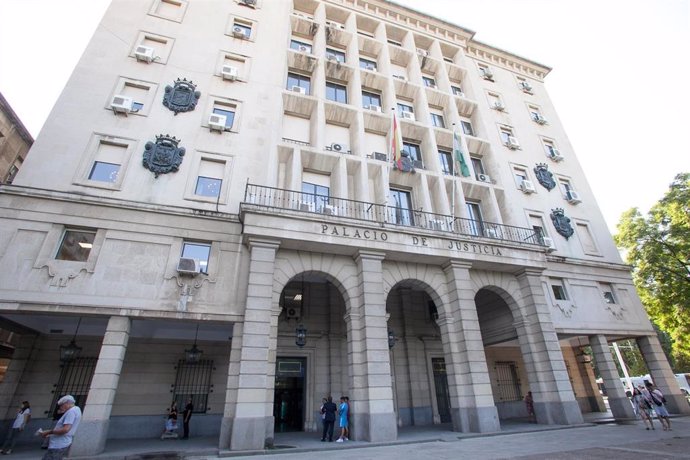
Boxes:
[513,269,583,425]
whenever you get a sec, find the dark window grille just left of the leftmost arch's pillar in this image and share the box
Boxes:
[170,359,215,414]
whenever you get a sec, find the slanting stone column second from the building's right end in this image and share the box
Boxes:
[589,335,635,420]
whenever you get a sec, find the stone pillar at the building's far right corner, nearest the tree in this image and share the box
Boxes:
[637,334,690,415]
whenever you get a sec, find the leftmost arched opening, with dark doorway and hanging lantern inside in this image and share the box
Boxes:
[273,272,348,433]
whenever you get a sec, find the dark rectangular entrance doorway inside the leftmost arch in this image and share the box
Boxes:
[273,357,307,433]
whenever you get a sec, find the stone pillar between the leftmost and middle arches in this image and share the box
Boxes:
[345,251,398,442]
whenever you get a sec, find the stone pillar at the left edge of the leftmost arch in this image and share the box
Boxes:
[226,239,278,450]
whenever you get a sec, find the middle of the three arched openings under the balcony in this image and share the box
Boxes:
[386,280,451,426]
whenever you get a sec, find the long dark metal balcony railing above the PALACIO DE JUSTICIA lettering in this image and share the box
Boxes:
[241,184,546,247]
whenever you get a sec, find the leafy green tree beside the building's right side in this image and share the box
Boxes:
[614,173,690,371]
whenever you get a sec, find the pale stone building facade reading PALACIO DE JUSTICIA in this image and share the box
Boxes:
[0,0,688,455]
